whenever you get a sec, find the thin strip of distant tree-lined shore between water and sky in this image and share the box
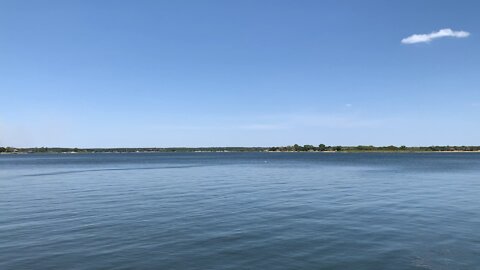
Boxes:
[0,144,480,154]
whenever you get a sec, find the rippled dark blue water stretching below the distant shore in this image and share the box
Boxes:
[0,153,480,270]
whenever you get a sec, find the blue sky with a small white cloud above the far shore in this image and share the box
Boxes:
[0,0,480,147]
